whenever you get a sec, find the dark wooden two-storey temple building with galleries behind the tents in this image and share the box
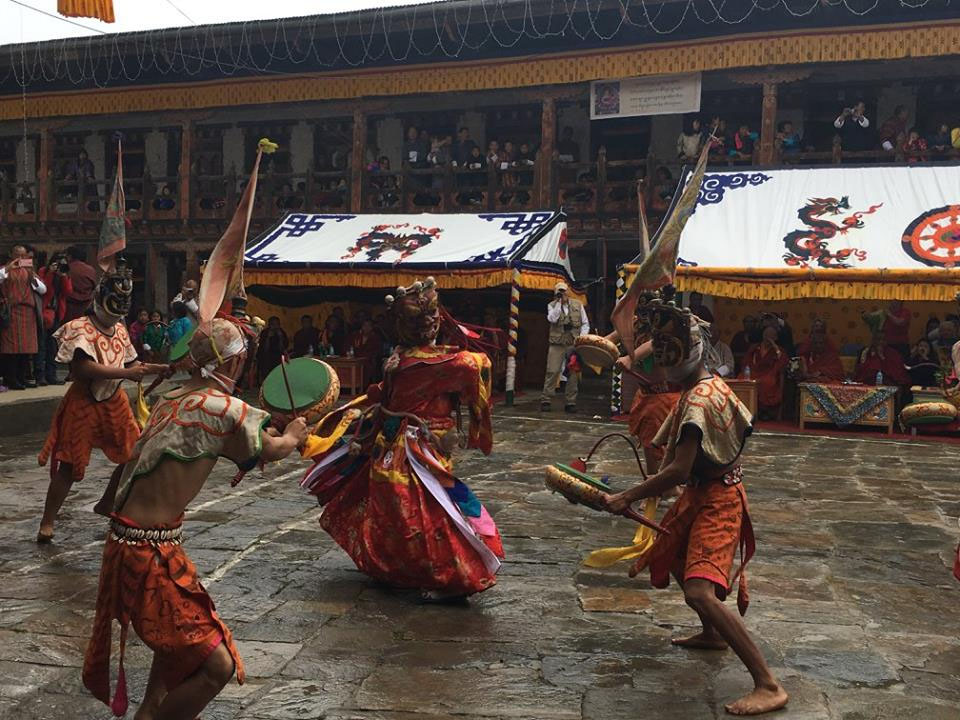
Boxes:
[0,0,960,317]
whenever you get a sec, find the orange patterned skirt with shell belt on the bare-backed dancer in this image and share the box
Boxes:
[83,515,244,716]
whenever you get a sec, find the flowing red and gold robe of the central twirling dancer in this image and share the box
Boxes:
[301,346,503,595]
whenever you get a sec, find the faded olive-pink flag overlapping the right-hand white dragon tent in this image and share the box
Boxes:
[610,140,710,355]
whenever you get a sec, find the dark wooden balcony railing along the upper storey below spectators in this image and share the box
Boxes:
[0,143,960,229]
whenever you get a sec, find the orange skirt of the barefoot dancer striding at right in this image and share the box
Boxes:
[634,476,756,615]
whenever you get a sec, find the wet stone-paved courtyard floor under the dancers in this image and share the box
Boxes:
[0,402,960,720]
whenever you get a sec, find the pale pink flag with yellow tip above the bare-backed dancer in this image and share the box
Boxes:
[197,138,277,325]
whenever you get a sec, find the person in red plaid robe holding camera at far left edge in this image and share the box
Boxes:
[0,245,47,390]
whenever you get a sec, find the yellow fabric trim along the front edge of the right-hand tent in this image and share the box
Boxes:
[624,265,960,302]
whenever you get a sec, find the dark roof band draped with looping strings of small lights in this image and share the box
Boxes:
[0,0,944,88]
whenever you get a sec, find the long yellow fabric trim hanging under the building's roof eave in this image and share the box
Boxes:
[0,20,960,120]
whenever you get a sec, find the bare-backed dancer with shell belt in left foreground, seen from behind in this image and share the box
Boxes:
[83,318,307,720]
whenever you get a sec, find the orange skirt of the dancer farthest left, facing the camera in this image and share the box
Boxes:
[37,382,140,482]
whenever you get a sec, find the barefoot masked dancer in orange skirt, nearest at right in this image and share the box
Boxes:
[607,300,787,715]
